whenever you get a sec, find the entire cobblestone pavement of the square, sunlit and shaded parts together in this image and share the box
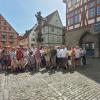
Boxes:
[0,59,100,100]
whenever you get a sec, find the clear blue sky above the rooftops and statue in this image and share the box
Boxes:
[0,0,66,34]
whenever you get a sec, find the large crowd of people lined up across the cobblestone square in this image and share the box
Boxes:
[0,45,86,71]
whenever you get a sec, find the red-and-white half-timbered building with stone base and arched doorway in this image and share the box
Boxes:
[63,0,100,57]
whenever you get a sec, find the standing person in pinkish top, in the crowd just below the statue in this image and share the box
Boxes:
[35,47,41,70]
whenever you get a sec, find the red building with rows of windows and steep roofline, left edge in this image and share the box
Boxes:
[0,15,18,47]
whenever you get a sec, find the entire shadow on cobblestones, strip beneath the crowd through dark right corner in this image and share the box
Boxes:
[0,58,100,84]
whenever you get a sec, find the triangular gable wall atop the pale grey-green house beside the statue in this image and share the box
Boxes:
[48,11,63,28]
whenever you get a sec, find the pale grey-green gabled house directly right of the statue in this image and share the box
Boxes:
[42,11,63,46]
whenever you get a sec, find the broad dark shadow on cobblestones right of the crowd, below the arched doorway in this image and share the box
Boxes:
[77,58,100,84]
